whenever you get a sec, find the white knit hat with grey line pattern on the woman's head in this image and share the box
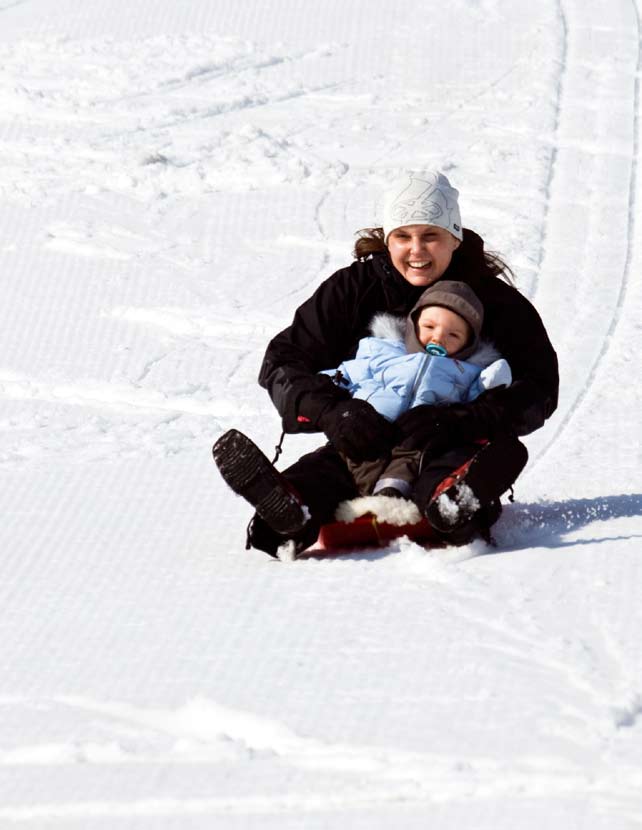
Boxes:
[383,170,463,244]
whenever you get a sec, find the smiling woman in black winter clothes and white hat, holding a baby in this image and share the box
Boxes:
[214,171,558,555]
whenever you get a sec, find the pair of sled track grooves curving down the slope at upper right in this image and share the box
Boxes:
[532,0,642,467]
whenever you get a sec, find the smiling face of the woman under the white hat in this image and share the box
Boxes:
[388,225,460,287]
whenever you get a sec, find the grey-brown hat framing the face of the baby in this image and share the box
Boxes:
[405,280,484,360]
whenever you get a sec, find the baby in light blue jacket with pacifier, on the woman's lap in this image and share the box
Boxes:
[324,280,512,497]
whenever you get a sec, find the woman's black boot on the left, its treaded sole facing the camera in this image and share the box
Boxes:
[212,429,306,534]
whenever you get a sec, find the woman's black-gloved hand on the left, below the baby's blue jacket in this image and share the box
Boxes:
[318,399,398,461]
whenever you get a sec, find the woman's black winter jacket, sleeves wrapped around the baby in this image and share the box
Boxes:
[259,230,559,442]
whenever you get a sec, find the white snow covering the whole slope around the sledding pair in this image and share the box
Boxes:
[0,0,642,830]
